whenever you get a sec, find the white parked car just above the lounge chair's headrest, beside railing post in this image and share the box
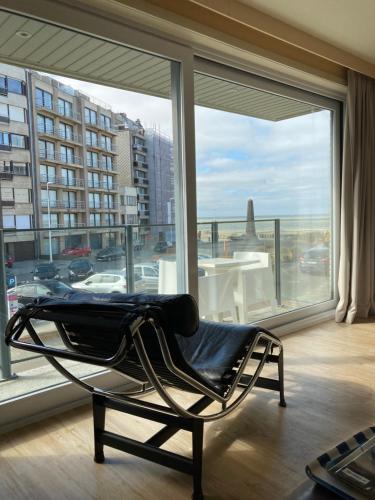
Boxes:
[72,271,144,293]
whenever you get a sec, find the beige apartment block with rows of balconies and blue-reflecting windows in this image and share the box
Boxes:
[28,72,120,255]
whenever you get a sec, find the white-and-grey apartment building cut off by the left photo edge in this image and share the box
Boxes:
[0,64,34,260]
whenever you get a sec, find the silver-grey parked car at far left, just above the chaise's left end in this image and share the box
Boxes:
[7,280,73,305]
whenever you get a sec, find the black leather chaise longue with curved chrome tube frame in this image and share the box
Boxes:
[6,292,285,499]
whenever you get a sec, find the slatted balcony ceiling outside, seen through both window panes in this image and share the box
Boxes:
[0,9,320,121]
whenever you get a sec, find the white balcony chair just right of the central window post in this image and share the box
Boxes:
[198,271,237,323]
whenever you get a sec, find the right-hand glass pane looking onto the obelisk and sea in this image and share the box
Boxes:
[195,74,333,322]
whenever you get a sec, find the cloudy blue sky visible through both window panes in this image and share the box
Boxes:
[54,77,331,219]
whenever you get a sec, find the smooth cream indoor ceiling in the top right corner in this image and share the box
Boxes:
[238,0,375,63]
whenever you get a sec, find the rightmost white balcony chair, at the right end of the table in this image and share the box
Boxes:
[234,266,276,323]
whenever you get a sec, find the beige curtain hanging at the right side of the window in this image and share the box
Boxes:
[336,71,375,323]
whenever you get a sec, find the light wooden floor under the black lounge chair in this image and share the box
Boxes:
[0,322,375,500]
